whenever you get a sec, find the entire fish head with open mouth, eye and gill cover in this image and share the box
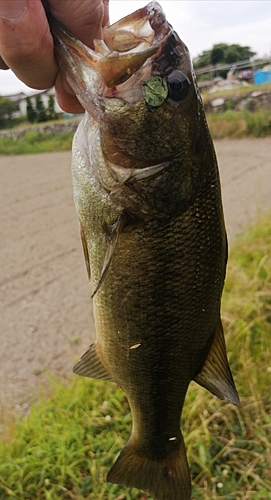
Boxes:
[51,2,212,219]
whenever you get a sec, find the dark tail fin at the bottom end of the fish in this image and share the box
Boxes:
[107,436,191,500]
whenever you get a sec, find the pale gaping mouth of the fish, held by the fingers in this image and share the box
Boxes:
[49,2,173,115]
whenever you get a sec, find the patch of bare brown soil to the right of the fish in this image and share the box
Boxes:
[215,138,271,245]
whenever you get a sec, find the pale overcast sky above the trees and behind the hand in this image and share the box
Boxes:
[0,0,271,95]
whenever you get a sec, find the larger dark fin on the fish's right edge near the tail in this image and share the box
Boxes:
[194,321,240,406]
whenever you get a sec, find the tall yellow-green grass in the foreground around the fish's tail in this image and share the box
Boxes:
[0,217,271,500]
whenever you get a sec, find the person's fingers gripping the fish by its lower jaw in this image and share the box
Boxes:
[0,0,109,113]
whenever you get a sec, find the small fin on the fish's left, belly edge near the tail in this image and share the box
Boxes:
[73,343,112,380]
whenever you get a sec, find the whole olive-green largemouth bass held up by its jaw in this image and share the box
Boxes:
[51,2,239,500]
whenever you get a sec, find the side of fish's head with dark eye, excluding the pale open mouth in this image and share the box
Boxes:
[101,28,204,168]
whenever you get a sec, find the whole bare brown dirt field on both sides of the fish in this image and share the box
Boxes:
[0,139,271,411]
